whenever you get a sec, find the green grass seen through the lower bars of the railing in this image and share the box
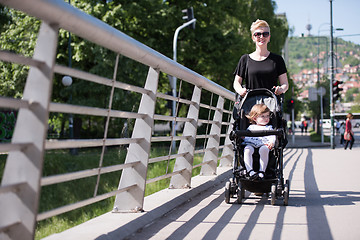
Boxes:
[0,145,207,239]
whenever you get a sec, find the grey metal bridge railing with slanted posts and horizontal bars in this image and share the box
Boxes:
[0,0,235,239]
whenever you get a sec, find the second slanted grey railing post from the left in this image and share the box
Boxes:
[113,67,159,212]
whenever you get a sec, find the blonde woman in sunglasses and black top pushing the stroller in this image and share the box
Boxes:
[233,19,289,97]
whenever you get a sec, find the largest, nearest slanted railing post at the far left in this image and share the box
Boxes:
[0,22,58,240]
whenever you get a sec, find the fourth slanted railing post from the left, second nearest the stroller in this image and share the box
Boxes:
[200,96,224,175]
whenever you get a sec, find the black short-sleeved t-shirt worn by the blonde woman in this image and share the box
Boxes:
[234,53,287,90]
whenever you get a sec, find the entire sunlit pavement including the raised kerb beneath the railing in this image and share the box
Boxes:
[45,131,360,240]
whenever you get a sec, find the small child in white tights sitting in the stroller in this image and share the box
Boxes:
[244,104,276,180]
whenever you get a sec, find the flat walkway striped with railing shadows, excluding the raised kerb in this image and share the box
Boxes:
[124,143,360,240]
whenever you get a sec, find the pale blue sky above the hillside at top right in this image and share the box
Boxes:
[270,0,360,44]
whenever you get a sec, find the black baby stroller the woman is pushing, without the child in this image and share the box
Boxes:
[225,89,290,205]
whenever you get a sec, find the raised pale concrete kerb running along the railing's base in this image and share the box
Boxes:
[44,167,232,240]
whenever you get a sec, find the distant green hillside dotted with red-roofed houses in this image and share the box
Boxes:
[287,37,360,112]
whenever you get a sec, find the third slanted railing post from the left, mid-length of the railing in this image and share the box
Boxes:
[170,86,201,188]
